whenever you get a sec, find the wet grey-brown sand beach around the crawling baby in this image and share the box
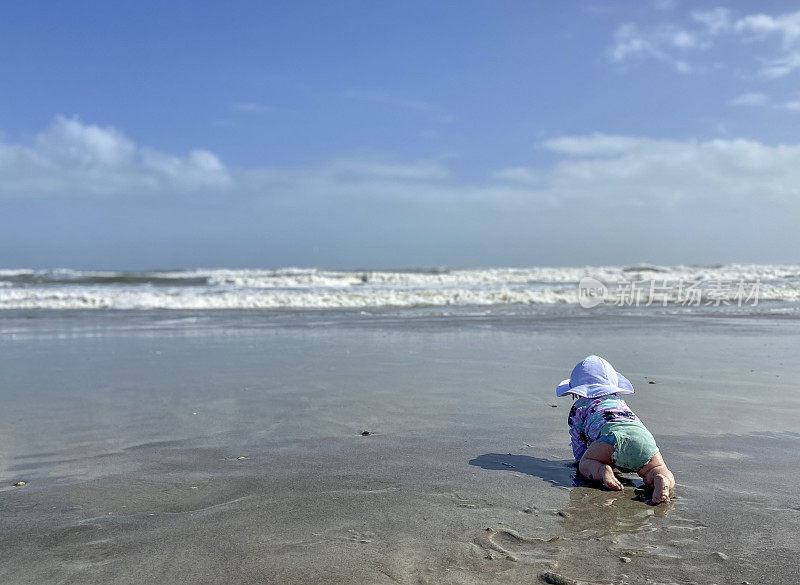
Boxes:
[0,314,800,584]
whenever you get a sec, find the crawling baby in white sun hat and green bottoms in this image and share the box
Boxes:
[556,355,675,504]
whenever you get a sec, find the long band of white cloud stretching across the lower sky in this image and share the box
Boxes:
[0,118,800,224]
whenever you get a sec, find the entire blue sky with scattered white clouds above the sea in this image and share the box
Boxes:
[0,0,800,269]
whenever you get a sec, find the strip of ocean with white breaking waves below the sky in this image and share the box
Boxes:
[0,264,800,315]
